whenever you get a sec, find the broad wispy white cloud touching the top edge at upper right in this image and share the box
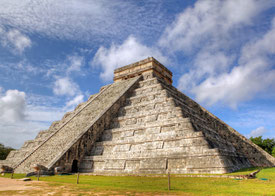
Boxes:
[159,0,272,52]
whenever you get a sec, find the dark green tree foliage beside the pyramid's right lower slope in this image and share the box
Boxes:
[250,136,275,157]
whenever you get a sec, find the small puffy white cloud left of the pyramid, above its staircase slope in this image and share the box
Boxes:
[53,77,79,96]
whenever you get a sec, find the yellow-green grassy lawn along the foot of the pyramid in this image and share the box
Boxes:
[0,168,275,195]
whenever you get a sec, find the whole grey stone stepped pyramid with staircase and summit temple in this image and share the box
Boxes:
[0,57,275,175]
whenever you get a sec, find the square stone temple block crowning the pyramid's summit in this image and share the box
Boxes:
[114,57,173,85]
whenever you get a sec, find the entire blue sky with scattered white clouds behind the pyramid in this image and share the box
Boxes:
[0,0,275,148]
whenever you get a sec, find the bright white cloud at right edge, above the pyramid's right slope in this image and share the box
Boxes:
[192,18,275,107]
